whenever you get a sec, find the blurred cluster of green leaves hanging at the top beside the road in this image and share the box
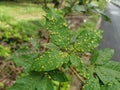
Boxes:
[63,0,111,22]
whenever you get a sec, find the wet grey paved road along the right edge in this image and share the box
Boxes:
[98,2,120,61]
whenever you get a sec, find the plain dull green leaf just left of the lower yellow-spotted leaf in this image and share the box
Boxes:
[11,47,39,72]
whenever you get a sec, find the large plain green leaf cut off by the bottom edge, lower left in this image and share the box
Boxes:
[7,72,54,90]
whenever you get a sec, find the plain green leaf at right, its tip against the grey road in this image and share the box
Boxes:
[95,49,114,65]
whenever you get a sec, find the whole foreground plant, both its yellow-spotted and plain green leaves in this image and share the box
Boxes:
[0,0,120,90]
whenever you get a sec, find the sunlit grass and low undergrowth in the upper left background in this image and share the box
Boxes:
[0,2,45,56]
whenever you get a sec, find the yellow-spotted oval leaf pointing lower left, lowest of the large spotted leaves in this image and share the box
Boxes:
[31,50,69,72]
